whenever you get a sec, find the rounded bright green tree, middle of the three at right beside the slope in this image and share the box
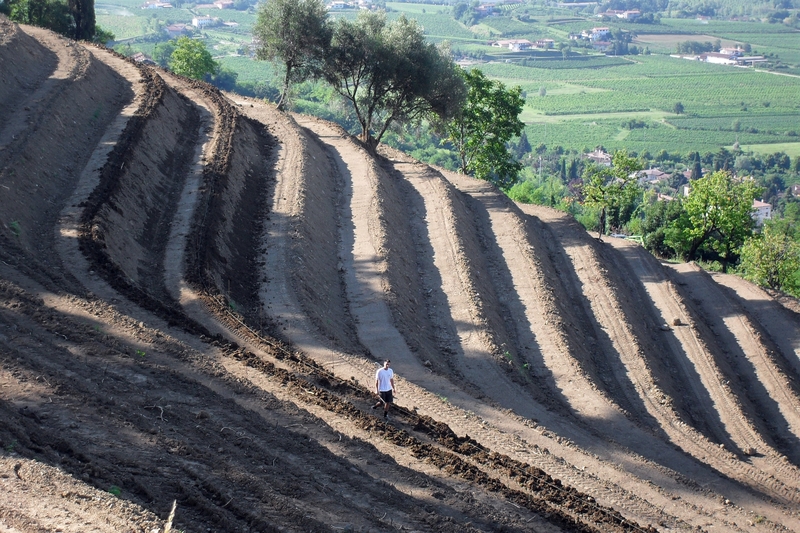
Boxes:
[666,170,759,271]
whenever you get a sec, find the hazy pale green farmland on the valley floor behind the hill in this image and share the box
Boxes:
[97,0,800,154]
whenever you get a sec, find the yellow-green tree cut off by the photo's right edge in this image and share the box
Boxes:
[740,223,800,296]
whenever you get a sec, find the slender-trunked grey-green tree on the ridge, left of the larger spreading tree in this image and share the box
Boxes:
[253,0,331,110]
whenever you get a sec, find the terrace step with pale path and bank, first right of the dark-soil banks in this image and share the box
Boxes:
[260,111,364,354]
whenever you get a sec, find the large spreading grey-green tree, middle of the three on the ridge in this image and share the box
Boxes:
[325,11,464,149]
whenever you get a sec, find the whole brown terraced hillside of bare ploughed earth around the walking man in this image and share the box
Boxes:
[0,19,800,532]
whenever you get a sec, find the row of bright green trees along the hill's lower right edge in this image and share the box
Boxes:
[575,152,800,295]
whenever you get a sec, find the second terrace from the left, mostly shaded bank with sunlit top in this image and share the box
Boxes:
[0,28,133,264]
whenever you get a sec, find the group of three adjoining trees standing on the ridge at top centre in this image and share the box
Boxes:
[253,0,524,187]
